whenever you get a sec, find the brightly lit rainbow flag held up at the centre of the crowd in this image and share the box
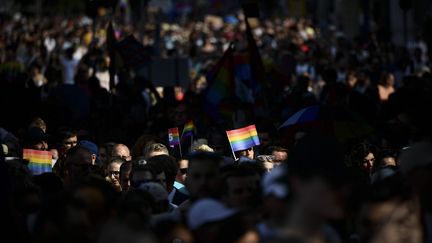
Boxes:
[226,125,260,152]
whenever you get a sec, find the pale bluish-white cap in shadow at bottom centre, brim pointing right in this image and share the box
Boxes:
[188,198,237,230]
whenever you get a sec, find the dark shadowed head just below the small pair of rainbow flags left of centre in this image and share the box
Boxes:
[147,154,178,192]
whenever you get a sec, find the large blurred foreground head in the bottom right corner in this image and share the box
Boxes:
[355,172,423,243]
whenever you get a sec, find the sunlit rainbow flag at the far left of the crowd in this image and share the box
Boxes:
[23,149,52,175]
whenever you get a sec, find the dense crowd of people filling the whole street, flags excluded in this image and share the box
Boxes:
[0,4,432,243]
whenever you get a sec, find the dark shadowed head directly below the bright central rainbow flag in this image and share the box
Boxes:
[222,163,260,208]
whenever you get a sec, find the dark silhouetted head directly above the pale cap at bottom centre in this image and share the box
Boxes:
[186,152,223,200]
